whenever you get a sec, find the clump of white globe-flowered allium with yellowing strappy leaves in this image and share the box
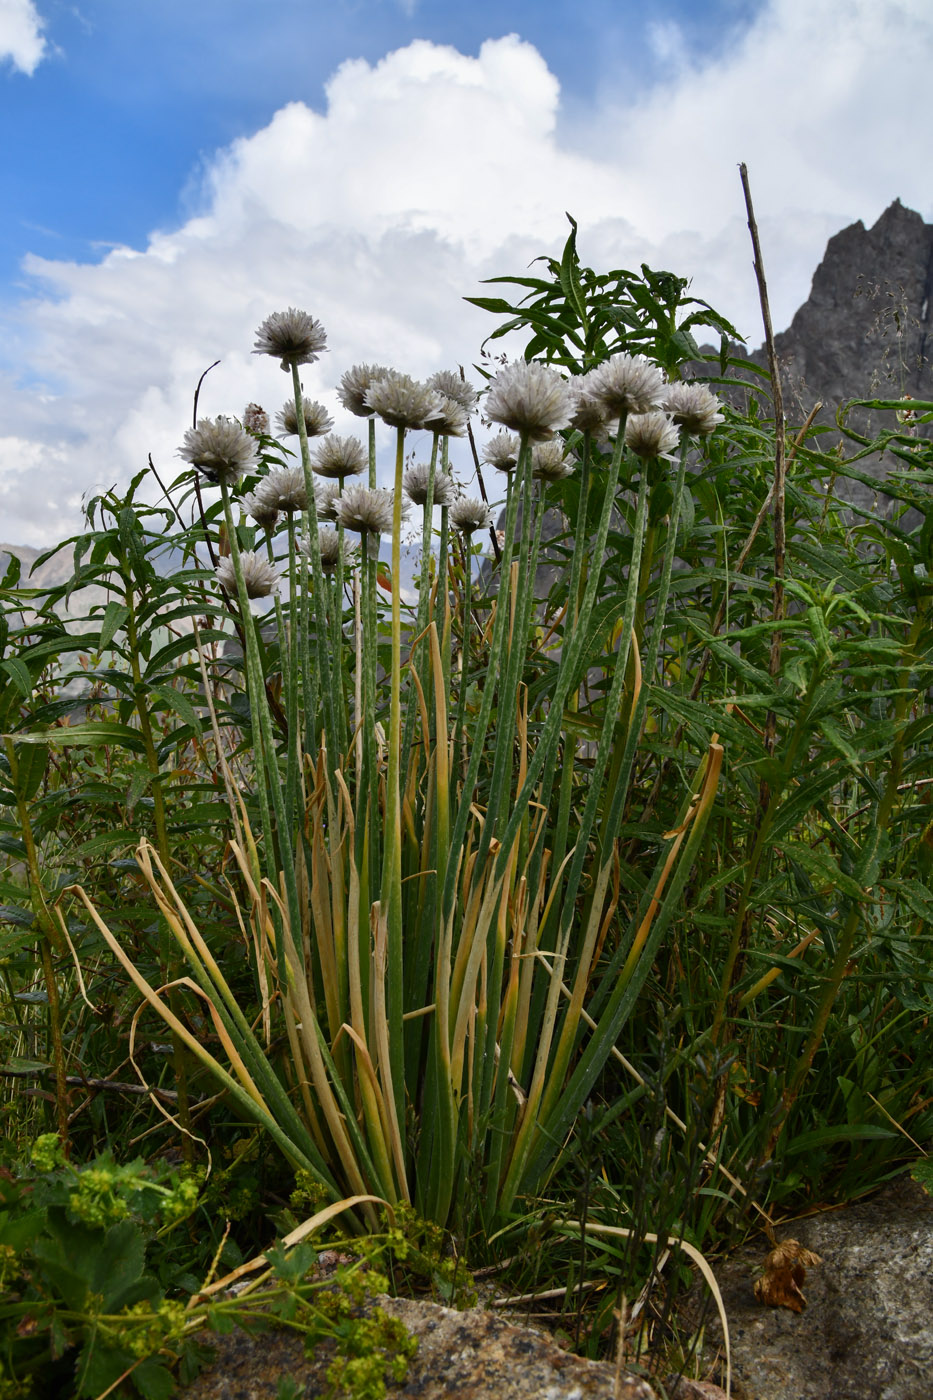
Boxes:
[85,267,721,1243]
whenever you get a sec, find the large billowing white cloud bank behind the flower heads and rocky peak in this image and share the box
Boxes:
[0,0,933,543]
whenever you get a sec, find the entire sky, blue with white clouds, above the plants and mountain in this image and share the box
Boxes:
[0,0,933,545]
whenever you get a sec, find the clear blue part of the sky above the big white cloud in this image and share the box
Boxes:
[0,0,754,283]
